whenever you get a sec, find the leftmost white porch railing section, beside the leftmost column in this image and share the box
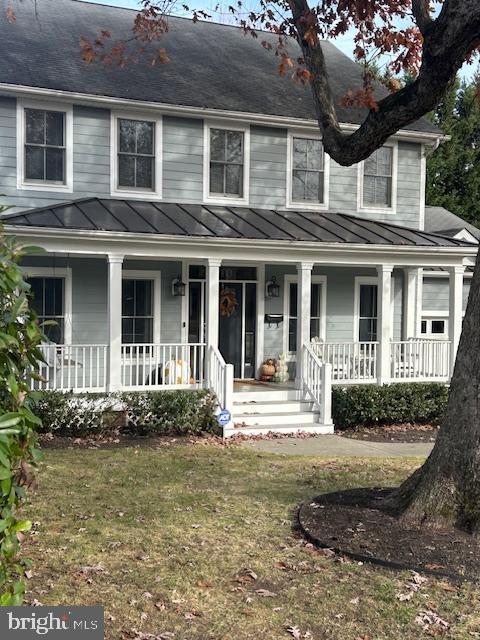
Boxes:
[31,343,108,392]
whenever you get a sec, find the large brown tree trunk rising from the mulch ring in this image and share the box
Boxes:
[389,248,480,533]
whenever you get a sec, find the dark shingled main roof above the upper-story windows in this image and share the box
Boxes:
[0,0,440,133]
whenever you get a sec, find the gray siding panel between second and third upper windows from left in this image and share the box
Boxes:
[163,116,203,202]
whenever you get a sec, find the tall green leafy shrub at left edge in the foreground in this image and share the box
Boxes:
[0,225,42,606]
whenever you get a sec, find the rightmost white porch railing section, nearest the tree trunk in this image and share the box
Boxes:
[390,339,451,382]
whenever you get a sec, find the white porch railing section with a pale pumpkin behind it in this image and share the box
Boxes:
[121,343,205,391]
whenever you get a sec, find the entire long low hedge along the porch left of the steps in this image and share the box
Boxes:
[30,389,218,437]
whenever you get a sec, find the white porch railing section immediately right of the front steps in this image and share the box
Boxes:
[311,342,378,384]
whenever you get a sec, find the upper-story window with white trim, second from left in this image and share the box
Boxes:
[111,114,161,198]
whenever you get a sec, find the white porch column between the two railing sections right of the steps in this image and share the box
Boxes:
[377,264,393,384]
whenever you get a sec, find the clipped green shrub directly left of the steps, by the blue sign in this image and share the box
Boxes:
[120,390,218,435]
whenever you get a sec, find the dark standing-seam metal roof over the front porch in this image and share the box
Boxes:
[3,198,472,247]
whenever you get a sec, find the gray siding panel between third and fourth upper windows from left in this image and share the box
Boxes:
[250,127,287,209]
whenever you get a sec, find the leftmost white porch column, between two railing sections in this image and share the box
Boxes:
[108,254,123,391]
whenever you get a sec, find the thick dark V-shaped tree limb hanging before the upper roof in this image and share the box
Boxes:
[289,0,480,166]
